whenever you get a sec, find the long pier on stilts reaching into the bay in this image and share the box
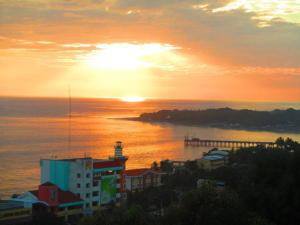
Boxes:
[184,136,277,148]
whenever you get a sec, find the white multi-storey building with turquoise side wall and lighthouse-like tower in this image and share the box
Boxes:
[40,142,127,212]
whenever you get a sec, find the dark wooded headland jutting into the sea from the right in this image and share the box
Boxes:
[135,108,300,133]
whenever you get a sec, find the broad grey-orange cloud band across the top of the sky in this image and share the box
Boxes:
[0,0,300,68]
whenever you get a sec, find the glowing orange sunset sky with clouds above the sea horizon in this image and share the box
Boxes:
[0,0,300,101]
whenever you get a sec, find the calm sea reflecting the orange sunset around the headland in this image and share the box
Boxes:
[0,98,300,198]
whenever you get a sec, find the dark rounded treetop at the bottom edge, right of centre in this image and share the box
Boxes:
[163,186,247,225]
